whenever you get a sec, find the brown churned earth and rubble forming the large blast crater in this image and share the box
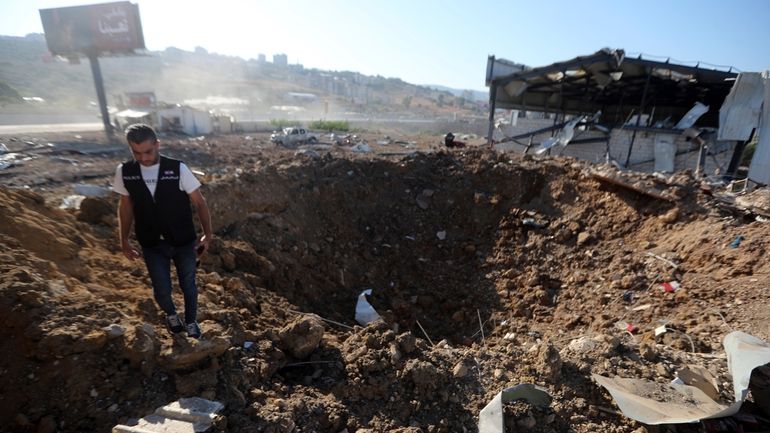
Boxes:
[0,133,770,433]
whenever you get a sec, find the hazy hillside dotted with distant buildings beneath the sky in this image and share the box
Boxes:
[0,34,482,118]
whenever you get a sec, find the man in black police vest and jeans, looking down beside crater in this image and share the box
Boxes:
[113,124,212,338]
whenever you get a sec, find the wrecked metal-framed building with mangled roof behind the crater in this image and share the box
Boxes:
[486,49,768,184]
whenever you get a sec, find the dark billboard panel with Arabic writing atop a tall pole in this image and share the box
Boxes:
[40,1,144,56]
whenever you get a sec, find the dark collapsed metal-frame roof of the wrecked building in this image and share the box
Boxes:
[487,48,738,126]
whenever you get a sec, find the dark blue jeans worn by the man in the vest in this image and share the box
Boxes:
[142,240,198,323]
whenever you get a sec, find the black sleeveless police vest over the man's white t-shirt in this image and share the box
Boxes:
[122,156,196,247]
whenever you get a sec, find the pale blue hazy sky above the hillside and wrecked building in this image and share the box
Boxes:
[0,0,770,90]
